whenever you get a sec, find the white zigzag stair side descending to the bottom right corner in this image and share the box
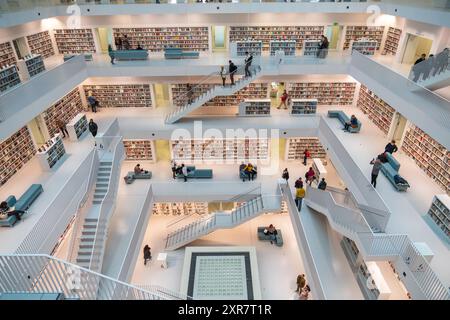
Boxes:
[305,187,450,300]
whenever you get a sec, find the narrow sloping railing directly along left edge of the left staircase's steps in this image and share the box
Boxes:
[67,149,99,263]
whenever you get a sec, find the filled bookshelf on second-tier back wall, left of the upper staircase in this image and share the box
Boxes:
[83,84,152,108]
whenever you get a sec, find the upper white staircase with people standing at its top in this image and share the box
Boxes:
[165,66,262,123]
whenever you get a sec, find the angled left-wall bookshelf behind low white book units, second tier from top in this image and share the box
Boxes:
[42,88,83,137]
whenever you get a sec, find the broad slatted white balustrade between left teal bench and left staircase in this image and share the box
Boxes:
[15,150,95,254]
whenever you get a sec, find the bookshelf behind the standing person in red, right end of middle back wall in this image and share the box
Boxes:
[285,137,327,161]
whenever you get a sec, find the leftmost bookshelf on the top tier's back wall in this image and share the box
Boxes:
[54,29,95,54]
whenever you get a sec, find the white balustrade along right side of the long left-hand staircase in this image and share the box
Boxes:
[89,136,125,272]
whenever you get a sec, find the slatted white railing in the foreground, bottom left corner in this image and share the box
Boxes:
[0,254,172,300]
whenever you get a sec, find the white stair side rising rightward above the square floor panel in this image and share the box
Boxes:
[166,196,281,251]
